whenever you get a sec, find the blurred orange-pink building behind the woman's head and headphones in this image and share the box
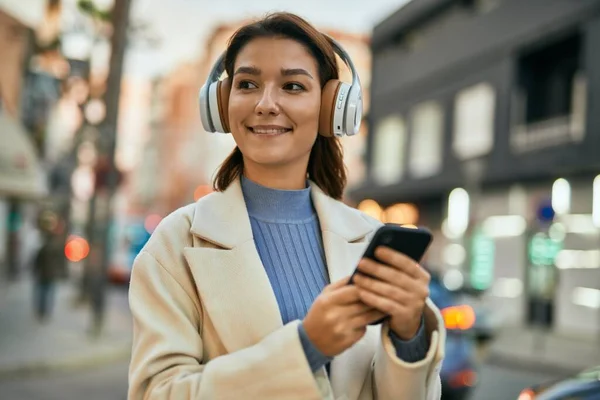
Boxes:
[136,20,371,215]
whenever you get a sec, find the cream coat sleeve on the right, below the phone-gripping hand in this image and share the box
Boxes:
[373,299,446,400]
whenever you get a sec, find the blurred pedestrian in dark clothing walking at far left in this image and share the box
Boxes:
[33,211,66,322]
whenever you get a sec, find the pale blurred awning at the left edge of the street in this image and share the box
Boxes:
[0,112,48,199]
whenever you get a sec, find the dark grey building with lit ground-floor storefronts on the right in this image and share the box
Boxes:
[351,0,600,337]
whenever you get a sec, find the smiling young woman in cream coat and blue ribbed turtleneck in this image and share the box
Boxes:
[129,13,445,400]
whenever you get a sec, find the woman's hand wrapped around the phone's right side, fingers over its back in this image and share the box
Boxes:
[354,247,431,340]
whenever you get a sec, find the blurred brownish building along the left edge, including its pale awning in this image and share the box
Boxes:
[0,0,48,279]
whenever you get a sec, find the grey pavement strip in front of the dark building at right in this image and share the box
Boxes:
[487,327,600,374]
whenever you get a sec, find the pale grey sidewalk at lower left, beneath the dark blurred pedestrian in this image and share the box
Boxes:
[0,278,132,378]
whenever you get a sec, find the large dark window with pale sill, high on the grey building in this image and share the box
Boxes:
[511,34,588,152]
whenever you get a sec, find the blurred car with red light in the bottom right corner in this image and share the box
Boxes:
[518,365,600,400]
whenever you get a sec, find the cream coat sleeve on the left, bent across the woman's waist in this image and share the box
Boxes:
[128,251,328,400]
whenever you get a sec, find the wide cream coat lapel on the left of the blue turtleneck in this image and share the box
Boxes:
[184,180,283,352]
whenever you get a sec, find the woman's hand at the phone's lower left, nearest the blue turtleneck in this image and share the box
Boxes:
[302,277,384,357]
